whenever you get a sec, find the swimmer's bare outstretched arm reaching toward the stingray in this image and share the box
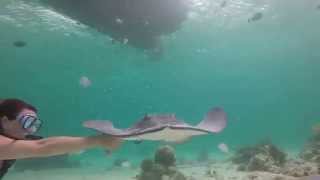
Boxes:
[0,135,120,160]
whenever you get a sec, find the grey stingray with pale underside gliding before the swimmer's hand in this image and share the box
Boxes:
[83,108,227,142]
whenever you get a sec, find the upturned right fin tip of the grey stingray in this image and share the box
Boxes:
[197,107,227,133]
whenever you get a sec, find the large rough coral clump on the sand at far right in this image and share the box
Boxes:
[232,138,320,177]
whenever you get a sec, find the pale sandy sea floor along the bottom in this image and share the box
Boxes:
[4,152,320,180]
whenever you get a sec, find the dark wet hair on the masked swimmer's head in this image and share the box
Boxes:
[0,99,38,120]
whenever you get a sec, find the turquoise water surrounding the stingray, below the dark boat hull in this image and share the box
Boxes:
[0,0,320,172]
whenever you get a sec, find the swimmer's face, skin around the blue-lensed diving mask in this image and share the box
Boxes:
[1,109,37,139]
